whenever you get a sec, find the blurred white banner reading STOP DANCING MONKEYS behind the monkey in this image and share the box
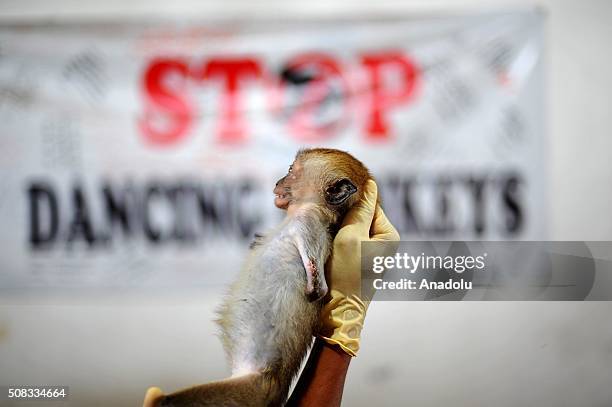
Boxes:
[0,12,545,290]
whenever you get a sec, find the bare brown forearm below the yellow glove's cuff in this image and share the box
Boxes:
[287,338,351,407]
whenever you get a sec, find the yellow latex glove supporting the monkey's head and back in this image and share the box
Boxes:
[319,180,400,356]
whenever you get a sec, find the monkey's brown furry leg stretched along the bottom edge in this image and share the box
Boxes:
[154,373,282,407]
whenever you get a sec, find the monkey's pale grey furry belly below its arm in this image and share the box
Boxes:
[218,260,322,376]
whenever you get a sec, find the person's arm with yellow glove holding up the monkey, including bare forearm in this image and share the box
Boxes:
[287,181,399,407]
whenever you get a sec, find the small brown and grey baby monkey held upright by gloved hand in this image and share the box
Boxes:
[156,148,371,407]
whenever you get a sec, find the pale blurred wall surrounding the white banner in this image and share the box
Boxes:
[0,0,612,406]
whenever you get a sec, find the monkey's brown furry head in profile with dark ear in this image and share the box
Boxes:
[274,148,372,223]
